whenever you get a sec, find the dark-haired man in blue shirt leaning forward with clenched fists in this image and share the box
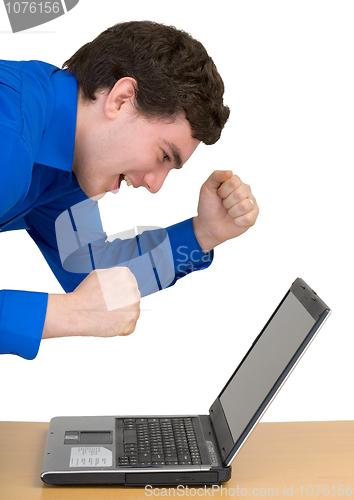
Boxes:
[0,21,258,359]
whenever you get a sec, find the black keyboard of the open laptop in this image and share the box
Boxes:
[118,418,202,467]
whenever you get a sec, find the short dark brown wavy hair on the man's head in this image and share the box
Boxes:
[63,21,230,144]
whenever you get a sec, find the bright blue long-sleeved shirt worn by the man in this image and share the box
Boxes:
[0,61,213,359]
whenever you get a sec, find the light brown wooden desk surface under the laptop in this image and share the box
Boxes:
[0,421,354,500]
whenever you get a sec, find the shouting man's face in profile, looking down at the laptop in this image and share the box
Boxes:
[73,86,200,197]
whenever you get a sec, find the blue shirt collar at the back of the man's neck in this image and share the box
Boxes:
[35,70,78,173]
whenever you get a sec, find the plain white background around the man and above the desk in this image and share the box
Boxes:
[0,0,354,421]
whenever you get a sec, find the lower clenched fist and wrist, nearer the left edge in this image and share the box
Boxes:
[42,267,140,338]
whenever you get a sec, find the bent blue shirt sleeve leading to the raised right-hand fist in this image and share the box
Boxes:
[26,192,213,297]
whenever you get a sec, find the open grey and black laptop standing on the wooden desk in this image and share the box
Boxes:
[41,278,331,486]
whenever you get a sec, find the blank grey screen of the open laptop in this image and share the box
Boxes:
[220,292,316,443]
